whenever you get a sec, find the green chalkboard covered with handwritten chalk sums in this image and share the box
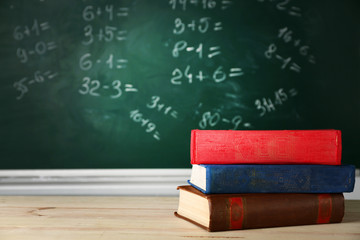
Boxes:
[0,0,360,169]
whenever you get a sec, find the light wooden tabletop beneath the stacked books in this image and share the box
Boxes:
[0,196,360,240]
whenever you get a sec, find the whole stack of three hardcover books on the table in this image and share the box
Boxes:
[175,130,355,231]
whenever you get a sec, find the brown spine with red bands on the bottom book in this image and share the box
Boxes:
[208,193,344,231]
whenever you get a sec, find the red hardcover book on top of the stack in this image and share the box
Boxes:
[190,130,341,165]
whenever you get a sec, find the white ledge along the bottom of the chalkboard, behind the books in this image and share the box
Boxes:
[0,169,360,200]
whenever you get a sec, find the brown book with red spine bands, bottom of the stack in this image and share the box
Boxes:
[175,186,344,232]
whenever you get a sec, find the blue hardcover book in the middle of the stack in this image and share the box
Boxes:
[189,164,355,194]
